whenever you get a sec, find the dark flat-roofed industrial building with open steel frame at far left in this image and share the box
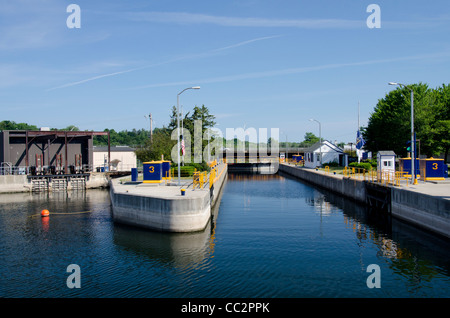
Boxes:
[0,130,110,175]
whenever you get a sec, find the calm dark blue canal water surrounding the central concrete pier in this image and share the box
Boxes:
[0,174,450,298]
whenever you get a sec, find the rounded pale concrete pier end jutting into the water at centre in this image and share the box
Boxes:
[110,164,227,232]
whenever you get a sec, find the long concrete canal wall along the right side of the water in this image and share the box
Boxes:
[279,164,450,238]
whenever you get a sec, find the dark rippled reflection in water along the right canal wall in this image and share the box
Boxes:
[283,171,450,295]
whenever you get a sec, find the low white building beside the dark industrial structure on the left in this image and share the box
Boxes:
[92,146,137,171]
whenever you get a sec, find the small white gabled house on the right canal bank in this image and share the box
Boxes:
[304,140,348,168]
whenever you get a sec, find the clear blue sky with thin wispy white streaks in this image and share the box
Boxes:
[0,0,450,142]
